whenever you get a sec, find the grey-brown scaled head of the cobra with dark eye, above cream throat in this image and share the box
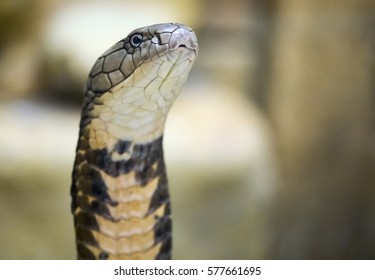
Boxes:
[87,23,198,94]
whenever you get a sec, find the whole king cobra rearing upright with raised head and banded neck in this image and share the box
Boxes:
[71,23,198,259]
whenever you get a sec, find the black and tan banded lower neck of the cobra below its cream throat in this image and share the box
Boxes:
[72,121,171,259]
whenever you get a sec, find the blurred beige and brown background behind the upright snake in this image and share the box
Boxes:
[0,0,375,259]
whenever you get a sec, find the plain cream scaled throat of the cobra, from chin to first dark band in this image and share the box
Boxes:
[89,50,192,151]
